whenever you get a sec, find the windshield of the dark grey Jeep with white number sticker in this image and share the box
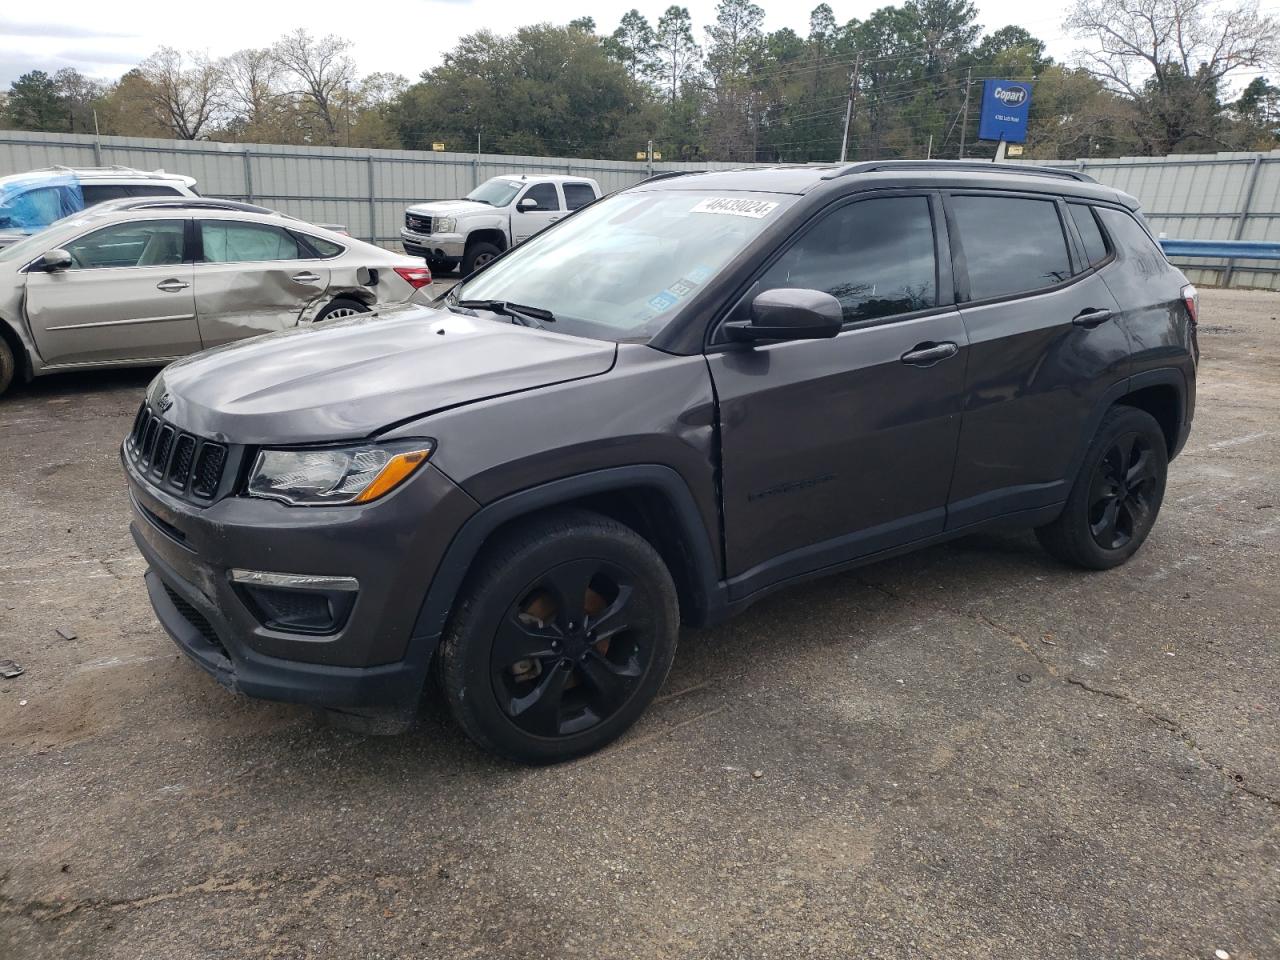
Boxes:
[445,191,795,340]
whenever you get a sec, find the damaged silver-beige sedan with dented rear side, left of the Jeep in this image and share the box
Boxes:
[0,198,431,394]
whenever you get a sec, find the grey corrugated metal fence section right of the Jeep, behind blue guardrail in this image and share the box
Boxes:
[1043,150,1280,289]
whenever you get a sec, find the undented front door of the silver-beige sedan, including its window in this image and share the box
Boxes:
[26,219,201,364]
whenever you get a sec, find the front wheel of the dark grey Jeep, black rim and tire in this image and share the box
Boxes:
[438,509,680,764]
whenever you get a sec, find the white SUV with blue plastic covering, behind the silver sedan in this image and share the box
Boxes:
[0,166,200,247]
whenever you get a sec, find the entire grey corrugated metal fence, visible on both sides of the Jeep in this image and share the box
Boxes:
[0,131,1280,289]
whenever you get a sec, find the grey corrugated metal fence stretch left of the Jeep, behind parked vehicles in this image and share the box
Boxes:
[0,131,757,252]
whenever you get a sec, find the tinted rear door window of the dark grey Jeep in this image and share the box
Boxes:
[951,196,1071,300]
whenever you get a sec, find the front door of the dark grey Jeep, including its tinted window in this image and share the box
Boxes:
[708,195,966,598]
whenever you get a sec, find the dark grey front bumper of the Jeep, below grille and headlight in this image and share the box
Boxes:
[122,448,476,710]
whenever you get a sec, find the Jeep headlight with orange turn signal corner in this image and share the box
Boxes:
[248,440,435,507]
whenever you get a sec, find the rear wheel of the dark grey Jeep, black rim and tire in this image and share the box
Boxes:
[1036,406,1169,570]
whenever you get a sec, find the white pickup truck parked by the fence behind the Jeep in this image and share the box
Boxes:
[401,175,600,276]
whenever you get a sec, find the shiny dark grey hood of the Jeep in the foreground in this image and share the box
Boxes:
[148,306,617,444]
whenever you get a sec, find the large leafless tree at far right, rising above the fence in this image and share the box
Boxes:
[1065,0,1280,154]
